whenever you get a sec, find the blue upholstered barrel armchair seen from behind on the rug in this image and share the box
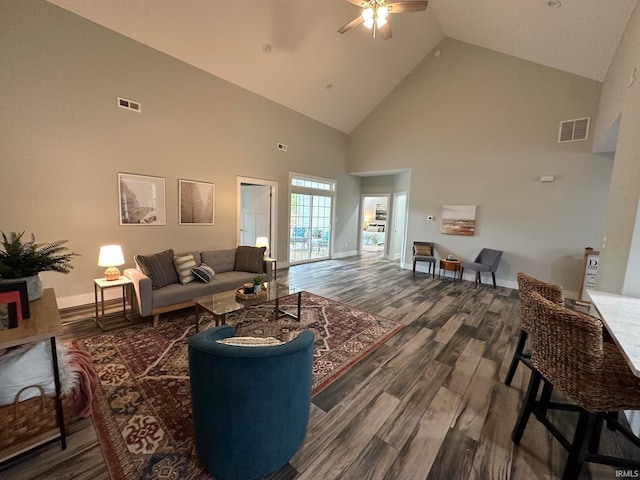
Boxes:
[189,325,314,479]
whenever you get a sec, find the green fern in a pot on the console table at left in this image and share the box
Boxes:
[0,232,78,301]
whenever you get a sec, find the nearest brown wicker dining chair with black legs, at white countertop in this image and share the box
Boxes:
[511,292,640,480]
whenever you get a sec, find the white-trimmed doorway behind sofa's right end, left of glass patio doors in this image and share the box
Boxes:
[237,177,278,258]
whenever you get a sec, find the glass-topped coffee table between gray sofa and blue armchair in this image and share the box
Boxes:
[193,281,303,332]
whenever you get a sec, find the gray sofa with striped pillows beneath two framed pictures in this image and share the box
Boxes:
[124,246,273,326]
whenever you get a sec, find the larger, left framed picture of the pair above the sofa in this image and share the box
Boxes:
[118,173,167,225]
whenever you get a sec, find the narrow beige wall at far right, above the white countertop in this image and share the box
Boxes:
[596,3,640,296]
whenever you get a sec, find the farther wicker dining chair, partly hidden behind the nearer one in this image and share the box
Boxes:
[504,272,564,386]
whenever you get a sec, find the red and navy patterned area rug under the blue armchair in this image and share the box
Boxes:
[78,292,403,480]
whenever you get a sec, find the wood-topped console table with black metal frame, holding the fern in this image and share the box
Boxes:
[0,288,67,463]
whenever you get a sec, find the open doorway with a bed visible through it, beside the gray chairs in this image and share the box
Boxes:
[360,194,389,258]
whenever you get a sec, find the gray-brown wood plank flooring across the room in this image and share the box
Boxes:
[0,253,640,480]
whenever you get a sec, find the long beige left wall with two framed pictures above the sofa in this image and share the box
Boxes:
[0,0,360,304]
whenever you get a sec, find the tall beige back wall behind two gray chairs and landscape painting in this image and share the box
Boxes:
[348,39,611,292]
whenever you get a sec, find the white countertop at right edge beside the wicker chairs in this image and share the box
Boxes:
[587,290,640,377]
